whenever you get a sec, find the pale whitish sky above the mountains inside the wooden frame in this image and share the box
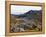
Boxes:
[11,5,41,15]
